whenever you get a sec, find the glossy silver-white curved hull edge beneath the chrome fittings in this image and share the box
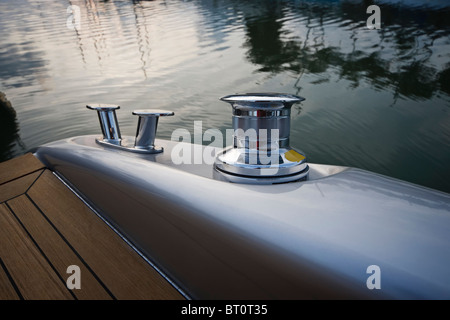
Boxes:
[35,136,450,299]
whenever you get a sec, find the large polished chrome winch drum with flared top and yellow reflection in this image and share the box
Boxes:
[214,93,309,184]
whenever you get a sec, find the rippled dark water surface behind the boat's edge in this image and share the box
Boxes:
[0,0,450,192]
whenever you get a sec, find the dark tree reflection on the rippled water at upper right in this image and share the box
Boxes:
[239,1,450,99]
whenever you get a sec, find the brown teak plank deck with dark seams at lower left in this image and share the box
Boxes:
[0,154,184,300]
